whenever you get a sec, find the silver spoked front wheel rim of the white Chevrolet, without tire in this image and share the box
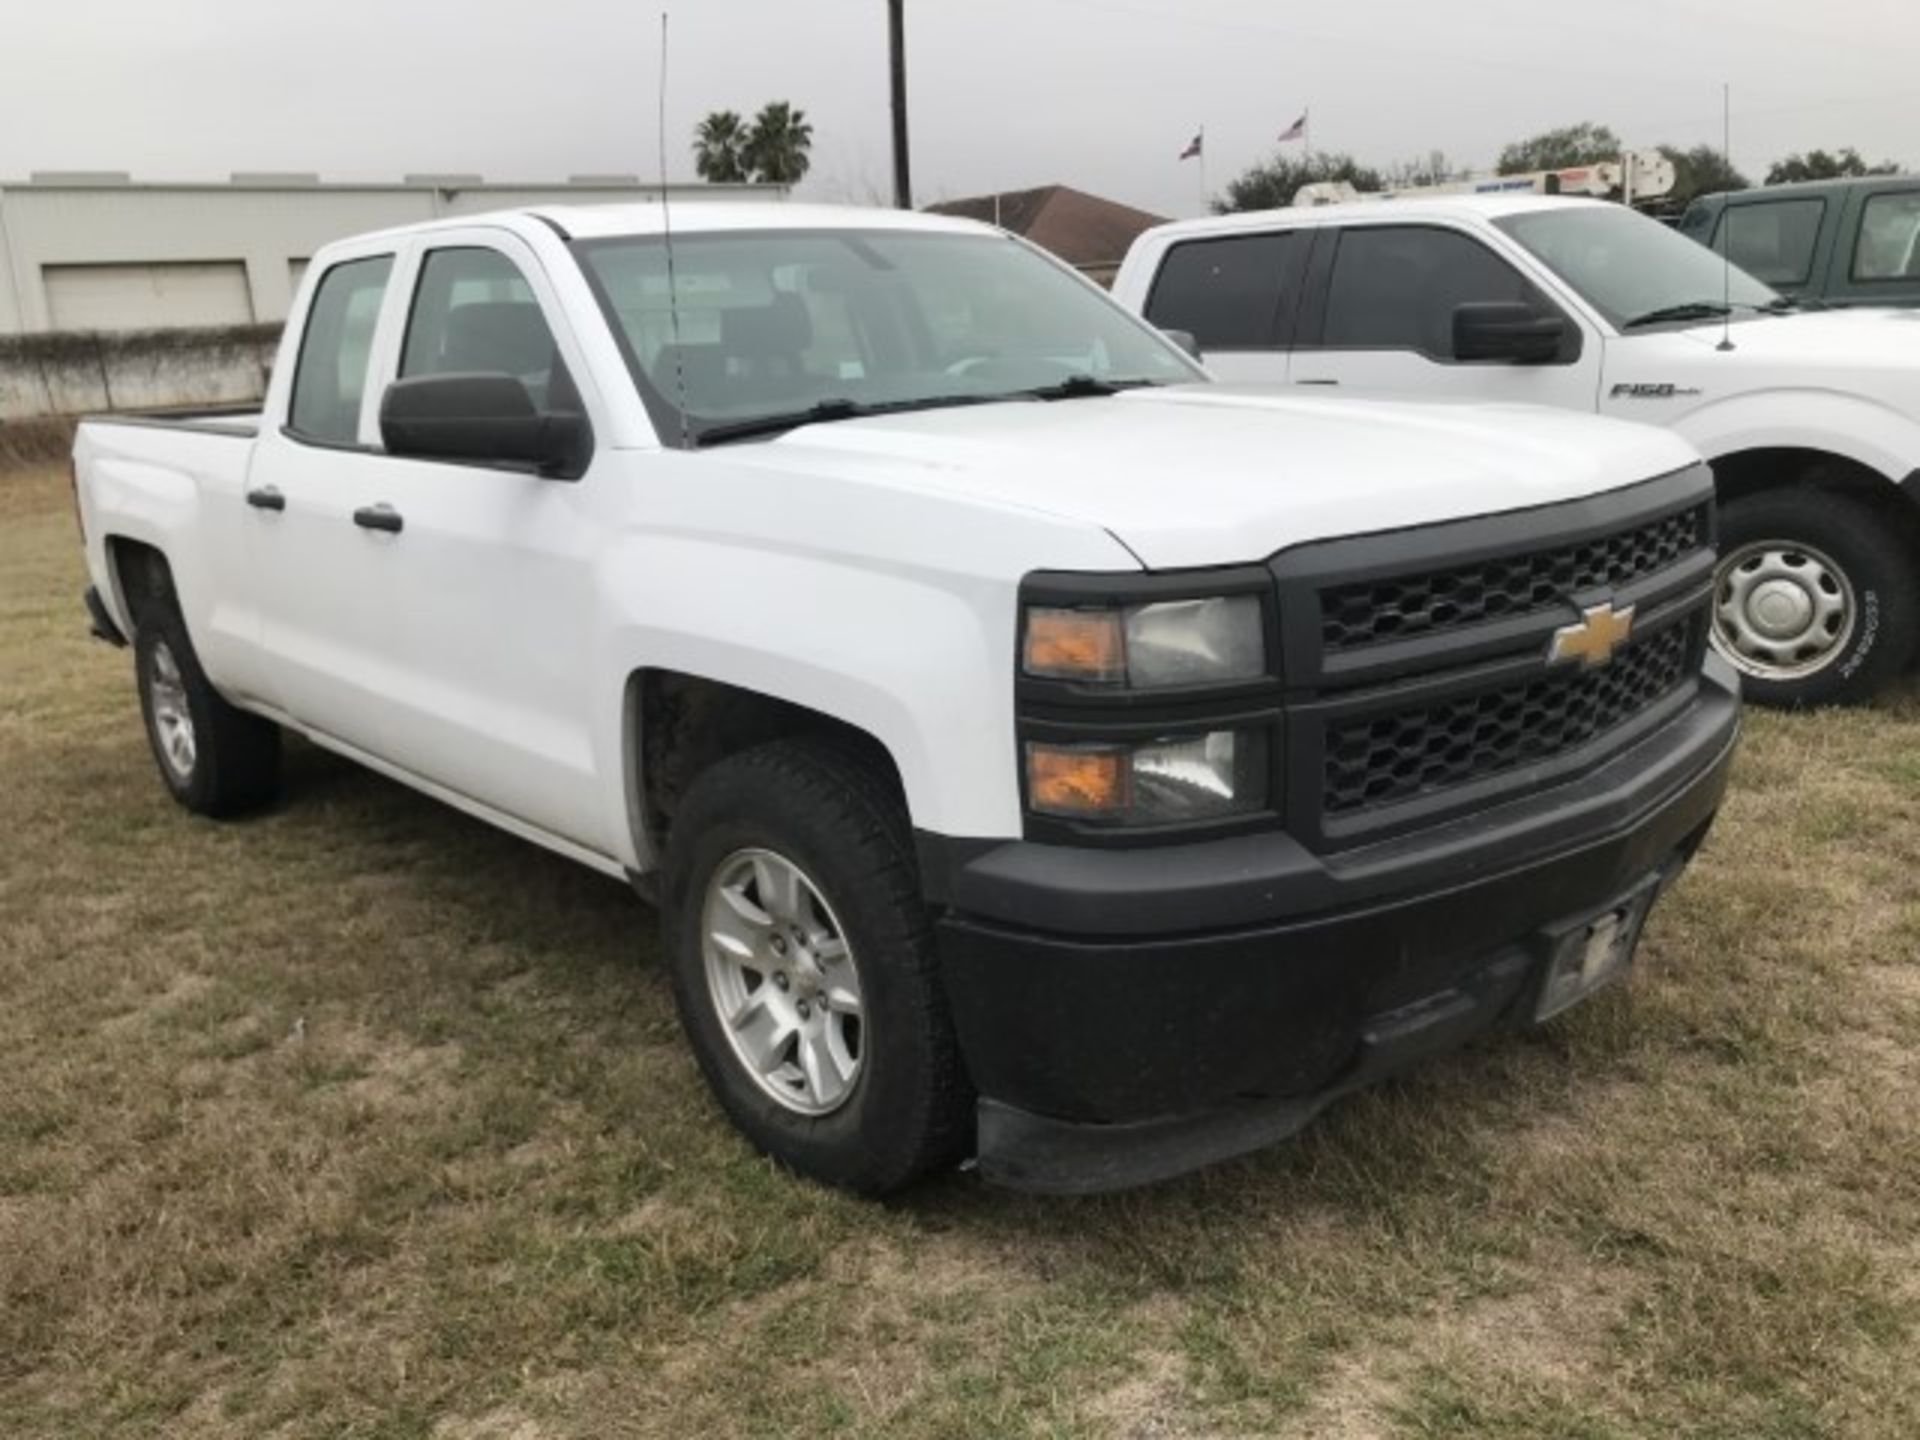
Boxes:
[701,849,866,1116]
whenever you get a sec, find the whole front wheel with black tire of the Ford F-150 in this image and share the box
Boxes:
[1713,486,1920,707]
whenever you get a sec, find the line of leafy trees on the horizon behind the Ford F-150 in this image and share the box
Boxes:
[1213,121,1901,215]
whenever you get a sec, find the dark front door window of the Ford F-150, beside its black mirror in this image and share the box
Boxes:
[1321,225,1551,359]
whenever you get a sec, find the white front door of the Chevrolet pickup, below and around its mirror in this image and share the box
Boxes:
[322,230,609,851]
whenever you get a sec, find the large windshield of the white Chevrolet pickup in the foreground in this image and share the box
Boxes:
[574,230,1206,444]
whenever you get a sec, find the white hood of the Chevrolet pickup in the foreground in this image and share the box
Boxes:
[755,384,1699,570]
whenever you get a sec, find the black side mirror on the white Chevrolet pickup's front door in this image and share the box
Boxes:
[380,374,593,480]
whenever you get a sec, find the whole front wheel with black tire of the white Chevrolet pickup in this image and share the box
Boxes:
[664,741,972,1194]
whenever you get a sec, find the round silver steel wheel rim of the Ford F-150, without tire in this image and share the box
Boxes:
[1713,540,1859,680]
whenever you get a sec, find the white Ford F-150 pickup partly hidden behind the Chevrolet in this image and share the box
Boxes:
[1114,196,1920,705]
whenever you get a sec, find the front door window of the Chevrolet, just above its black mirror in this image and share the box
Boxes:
[399,248,580,411]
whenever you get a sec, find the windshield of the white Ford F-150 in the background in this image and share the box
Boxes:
[1494,205,1782,326]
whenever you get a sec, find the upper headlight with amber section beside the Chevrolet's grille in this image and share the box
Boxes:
[1021,595,1267,689]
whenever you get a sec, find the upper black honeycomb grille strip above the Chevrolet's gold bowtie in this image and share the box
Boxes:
[1321,505,1711,653]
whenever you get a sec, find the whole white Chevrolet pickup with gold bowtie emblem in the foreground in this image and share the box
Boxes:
[75,205,1738,1192]
